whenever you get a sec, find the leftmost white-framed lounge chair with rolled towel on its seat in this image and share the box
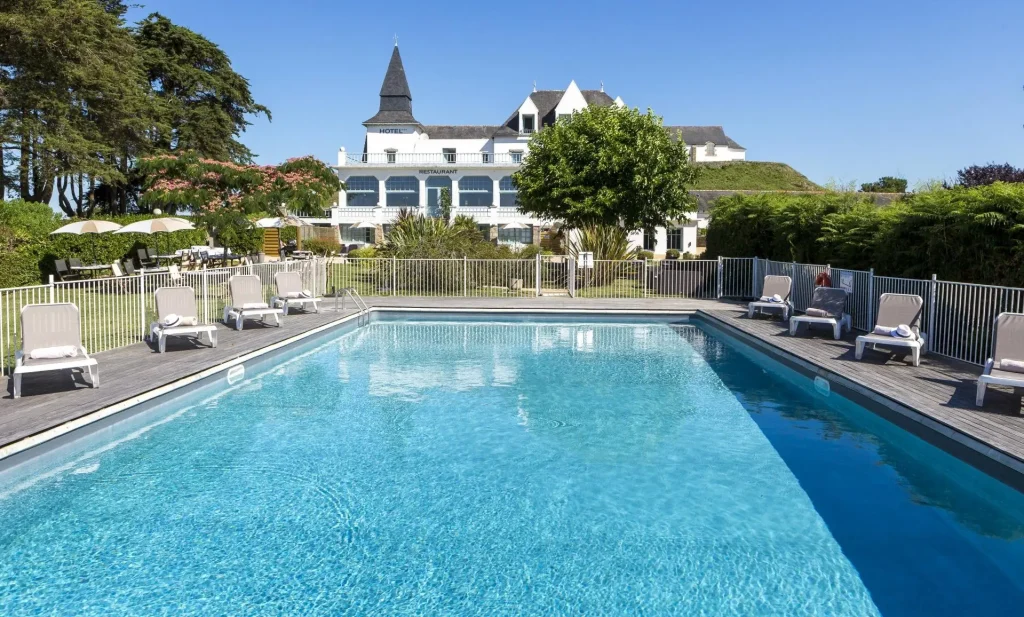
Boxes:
[13,303,99,398]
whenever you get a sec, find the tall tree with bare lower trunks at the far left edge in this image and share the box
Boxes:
[0,0,147,209]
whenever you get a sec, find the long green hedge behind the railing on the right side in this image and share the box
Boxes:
[707,183,1024,287]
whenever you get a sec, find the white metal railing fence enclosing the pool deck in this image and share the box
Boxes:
[8,256,1024,370]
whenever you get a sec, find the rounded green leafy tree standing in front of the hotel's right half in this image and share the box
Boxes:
[512,106,697,230]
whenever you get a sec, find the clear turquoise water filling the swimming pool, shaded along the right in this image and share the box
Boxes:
[0,319,1024,617]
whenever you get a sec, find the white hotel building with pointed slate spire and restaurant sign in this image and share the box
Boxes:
[327,45,746,254]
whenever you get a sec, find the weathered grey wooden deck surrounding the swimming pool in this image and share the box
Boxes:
[0,297,1024,482]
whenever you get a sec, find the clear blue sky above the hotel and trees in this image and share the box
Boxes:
[123,0,1024,186]
